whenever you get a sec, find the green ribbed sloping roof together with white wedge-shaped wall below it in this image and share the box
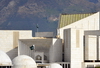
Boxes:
[58,12,100,39]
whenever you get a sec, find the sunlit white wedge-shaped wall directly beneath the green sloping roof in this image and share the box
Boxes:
[59,12,100,39]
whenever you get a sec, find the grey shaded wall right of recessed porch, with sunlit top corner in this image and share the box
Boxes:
[49,38,62,63]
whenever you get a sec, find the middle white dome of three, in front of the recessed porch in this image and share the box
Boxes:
[13,55,37,68]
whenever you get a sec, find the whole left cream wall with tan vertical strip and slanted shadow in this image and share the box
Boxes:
[0,30,32,59]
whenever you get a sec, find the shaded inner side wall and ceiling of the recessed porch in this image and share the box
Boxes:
[18,38,52,61]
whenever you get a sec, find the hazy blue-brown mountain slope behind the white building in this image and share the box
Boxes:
[0,0,100,35]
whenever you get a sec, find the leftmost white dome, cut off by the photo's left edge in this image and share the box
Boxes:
[0,51,12,66]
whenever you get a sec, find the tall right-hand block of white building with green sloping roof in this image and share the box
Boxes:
[58,12,100,68]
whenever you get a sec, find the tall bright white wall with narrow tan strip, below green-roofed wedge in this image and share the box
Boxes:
[71,29,84,68]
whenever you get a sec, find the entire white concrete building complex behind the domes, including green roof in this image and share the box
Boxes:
[0,12,100,68]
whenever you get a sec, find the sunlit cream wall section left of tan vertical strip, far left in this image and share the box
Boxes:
[0,30,13,52]
